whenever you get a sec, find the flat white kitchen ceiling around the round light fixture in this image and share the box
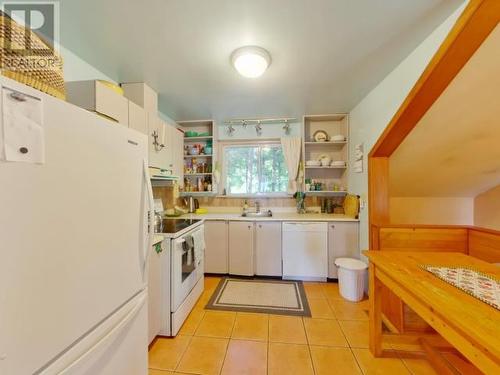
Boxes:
[61,0,462,120]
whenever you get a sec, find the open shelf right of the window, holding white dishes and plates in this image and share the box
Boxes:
[302,113,349,195]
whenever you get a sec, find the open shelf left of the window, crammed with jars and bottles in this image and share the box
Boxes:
[178,120,216,196]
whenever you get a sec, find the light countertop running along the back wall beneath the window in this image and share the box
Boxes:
[181,212,359,222]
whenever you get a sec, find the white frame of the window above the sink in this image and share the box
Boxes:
[218,139,291,198]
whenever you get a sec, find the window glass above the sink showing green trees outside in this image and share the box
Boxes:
[224,144,288,195]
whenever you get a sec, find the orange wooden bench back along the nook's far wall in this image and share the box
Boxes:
[380,228,468,253]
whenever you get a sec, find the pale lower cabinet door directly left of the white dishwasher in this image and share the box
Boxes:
[255,222,283,276]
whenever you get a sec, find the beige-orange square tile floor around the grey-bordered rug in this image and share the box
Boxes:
[149,277,435,375]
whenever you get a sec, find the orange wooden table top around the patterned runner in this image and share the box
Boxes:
[364,251,500,359]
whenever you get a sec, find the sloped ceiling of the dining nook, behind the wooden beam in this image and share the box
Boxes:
[390,26,500,197]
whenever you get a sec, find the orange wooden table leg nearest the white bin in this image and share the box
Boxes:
[369,262,382,357]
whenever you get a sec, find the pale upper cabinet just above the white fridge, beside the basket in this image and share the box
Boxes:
[66,81,129,126]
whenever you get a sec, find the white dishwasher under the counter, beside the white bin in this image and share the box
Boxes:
[282,222,328,281]
